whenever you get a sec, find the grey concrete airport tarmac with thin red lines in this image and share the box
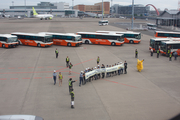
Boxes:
[0,18,180,120]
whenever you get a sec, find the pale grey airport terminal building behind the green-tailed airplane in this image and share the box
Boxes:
[0,2,78,18]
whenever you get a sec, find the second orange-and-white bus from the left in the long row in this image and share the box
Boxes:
[11,32,53,47]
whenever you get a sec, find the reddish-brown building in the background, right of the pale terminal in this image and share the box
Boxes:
[73,2,110,14]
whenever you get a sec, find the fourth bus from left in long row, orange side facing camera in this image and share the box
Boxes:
[77,32,124,46]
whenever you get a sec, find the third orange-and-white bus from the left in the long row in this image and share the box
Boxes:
[39,32,82,46]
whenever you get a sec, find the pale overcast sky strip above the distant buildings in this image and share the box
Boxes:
[0,0,178,10]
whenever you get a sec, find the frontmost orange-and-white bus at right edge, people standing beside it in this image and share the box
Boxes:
[160,41,180,56]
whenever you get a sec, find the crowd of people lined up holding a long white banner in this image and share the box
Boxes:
[79,56,127,86]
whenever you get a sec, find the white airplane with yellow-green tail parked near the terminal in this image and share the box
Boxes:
[32,7,54,20]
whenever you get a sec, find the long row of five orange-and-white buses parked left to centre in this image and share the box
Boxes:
[0,31,141,48]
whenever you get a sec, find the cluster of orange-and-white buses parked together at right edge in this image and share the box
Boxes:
[149,31,180,56]
